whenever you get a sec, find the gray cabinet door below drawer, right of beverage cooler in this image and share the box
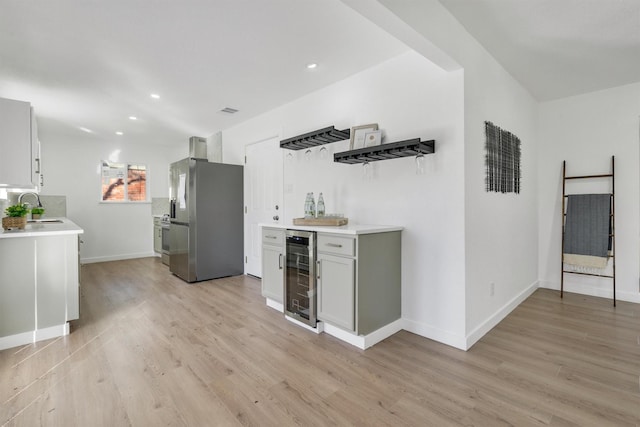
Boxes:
[318,254,356,331]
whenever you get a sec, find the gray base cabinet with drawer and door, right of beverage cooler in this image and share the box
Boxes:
[317,231,401,335]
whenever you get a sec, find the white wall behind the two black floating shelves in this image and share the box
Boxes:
[223,52,465,348]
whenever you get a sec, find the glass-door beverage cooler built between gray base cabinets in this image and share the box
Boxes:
[285,230,316,327]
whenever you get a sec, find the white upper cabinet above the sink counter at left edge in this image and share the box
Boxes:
[0,98,40,188]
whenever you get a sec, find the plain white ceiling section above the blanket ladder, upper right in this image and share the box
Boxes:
[439,0,640,101]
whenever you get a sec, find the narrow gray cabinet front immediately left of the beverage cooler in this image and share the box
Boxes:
[262,227,284,303]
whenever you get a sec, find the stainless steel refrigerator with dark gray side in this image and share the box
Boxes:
[169,158,244,282]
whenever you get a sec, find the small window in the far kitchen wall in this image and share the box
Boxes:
[102,160,147,202]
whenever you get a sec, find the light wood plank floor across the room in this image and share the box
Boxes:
[0,258,640,426]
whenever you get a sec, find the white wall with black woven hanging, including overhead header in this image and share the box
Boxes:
[378,0,538,348]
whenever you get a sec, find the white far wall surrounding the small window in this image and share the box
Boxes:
[40,134,180,262]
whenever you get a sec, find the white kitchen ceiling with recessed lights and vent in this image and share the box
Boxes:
[0,0,407,146]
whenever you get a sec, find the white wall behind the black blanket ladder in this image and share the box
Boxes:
[538,82,640,303]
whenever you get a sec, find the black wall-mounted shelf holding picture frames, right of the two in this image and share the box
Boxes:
[333,138,436,164]
